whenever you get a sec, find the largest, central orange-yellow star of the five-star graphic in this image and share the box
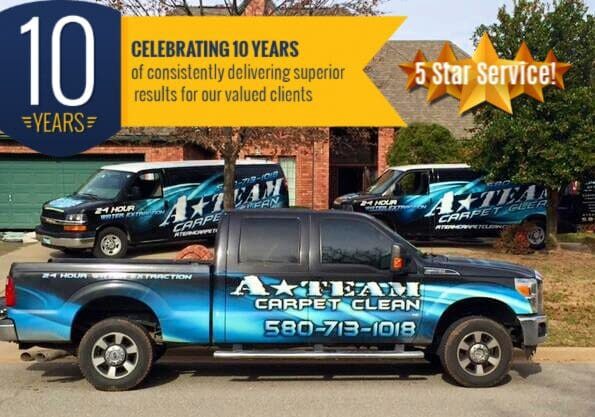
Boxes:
[459,33,518,114]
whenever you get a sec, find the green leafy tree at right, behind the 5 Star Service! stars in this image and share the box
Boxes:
[470,0,595,246]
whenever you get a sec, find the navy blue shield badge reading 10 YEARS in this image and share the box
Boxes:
[0,0,121,156]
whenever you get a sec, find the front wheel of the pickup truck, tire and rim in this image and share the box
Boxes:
[439,316,513,387]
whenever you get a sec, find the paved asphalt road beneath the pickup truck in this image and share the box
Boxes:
[0,357,595,417]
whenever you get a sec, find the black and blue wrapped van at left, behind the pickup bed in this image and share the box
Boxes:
[36,160,289,258]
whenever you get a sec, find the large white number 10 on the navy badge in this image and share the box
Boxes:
[21,16,95,107]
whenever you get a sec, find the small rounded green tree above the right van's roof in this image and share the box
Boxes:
[386,123,463,165]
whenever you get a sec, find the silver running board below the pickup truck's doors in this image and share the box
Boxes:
[213,350,424,359]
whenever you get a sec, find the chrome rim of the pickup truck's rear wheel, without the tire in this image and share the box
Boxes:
[91,332,138,379]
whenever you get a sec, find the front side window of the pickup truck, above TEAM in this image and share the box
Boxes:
[320,219,393,270]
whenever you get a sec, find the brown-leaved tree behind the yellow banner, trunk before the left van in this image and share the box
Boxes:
[95,0,379,210]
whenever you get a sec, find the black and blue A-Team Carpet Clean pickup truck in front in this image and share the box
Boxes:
[0,209,547,391]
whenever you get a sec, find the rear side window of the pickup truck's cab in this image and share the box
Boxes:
[239,217,300,264]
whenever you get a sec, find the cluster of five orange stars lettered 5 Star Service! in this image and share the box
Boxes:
[399,33,571,114]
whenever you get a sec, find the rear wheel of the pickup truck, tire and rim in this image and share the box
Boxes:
[78,318,155,391]
